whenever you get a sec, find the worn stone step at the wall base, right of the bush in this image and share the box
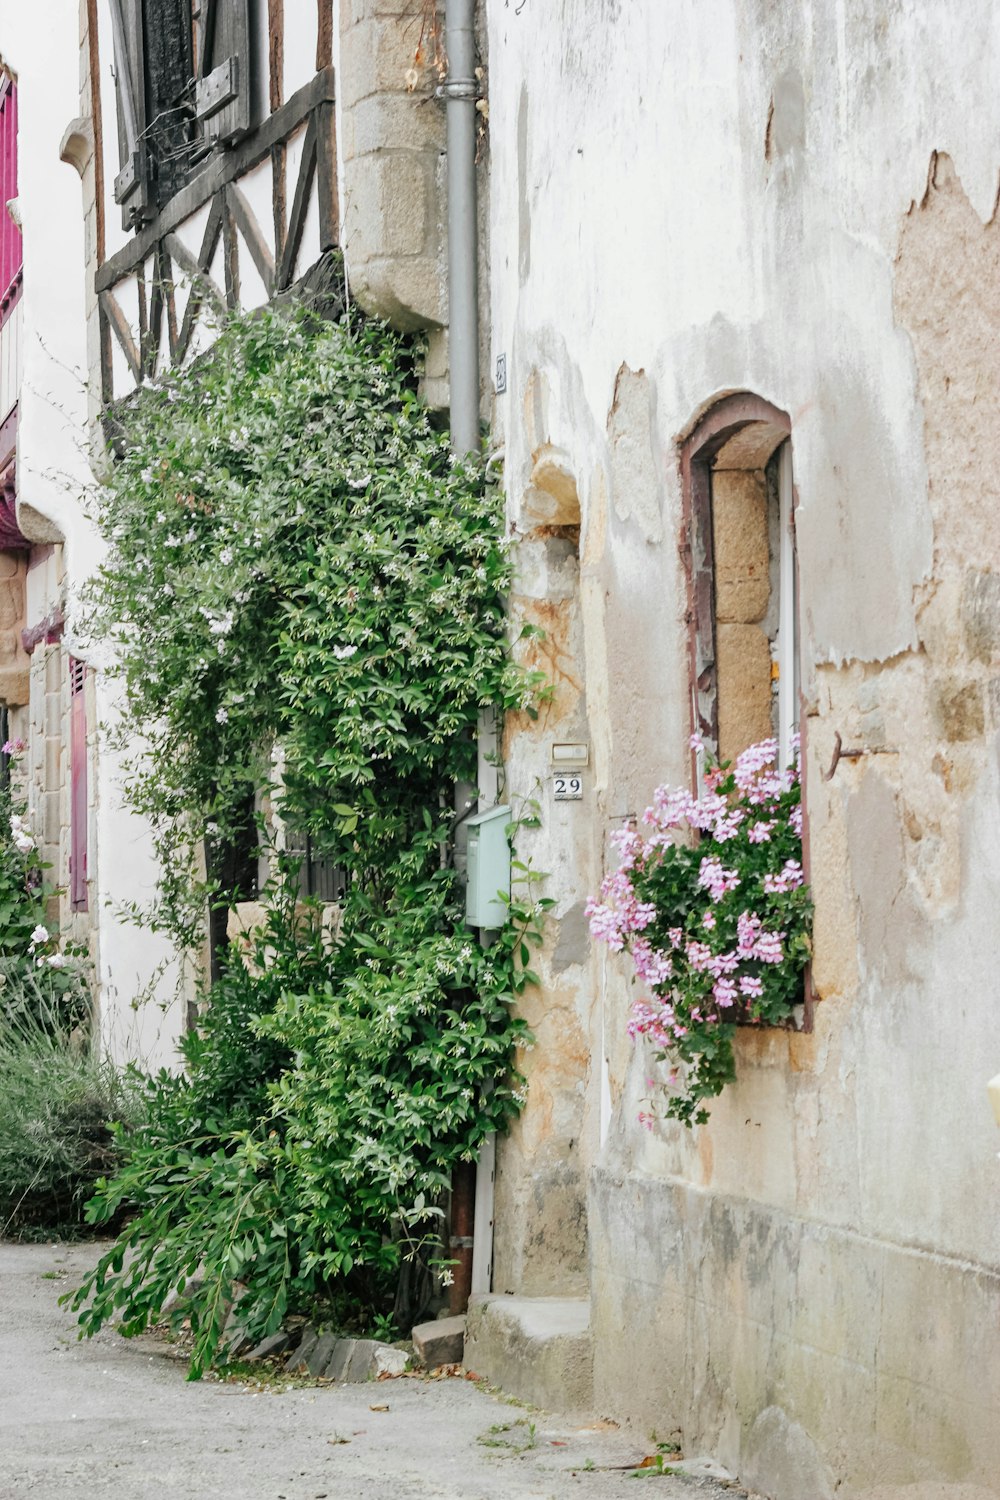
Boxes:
[465,1293,594,1413]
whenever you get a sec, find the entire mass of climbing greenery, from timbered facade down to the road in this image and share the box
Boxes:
[68,289,546,1376]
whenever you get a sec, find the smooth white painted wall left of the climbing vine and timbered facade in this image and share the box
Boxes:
[0,0,183,1067]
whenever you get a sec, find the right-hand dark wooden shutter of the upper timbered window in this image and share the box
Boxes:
[195,0,255,146]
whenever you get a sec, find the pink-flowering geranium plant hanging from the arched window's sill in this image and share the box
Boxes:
[588,740,813,1125]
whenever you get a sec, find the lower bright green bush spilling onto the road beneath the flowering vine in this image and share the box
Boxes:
[73,879,526,1379]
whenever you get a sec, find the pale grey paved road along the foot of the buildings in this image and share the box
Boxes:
[0,1244,744,1500]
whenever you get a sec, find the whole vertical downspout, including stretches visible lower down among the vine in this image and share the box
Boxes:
[441,0,481,1313]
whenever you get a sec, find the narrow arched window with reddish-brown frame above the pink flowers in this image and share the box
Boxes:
[681,395,799,762]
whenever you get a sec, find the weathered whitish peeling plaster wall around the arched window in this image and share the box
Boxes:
[487,0,1000,1500]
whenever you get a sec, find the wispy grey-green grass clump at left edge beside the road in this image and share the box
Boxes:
[0,971,136,1236]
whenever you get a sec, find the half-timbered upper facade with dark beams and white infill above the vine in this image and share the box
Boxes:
[90,0,339,402]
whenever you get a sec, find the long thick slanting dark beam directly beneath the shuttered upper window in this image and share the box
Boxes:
[96,68,334,291]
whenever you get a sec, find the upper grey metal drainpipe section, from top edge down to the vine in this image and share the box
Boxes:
[441,0,480,453]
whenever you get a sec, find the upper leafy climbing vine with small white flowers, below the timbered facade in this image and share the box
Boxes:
[93,301,529,941]
